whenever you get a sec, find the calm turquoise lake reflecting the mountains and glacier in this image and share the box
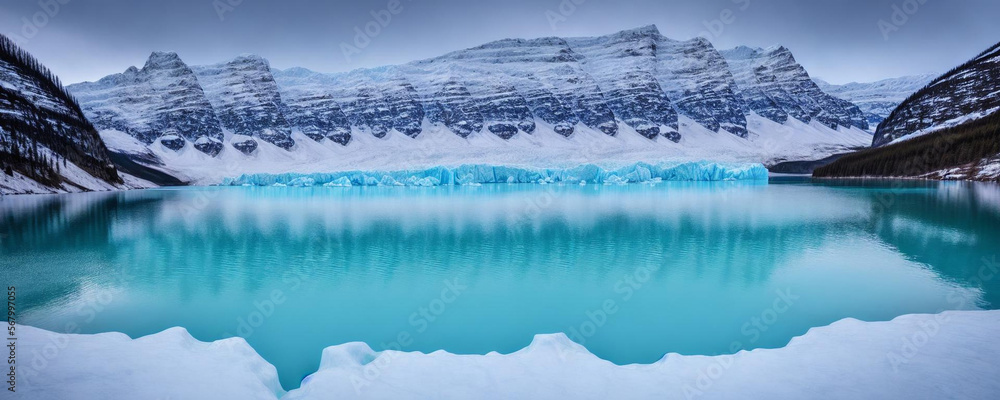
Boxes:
[0,179,1000,389]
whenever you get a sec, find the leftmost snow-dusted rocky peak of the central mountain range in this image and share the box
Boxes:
[69,52,223,155]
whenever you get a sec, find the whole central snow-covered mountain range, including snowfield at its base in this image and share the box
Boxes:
[69,26,871,182]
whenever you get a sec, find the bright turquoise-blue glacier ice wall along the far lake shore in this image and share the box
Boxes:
[222,161,768,187]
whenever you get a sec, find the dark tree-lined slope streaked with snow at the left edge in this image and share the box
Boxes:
[0,35,124,194]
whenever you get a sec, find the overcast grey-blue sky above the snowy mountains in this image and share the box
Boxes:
[0,0,1000,83]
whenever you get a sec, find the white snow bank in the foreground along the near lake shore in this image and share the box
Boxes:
[18,311,1000,400]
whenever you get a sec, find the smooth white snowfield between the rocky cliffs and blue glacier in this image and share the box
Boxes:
[117,114,871,185]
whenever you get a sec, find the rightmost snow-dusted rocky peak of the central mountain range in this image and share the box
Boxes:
[722,46,868,129]
